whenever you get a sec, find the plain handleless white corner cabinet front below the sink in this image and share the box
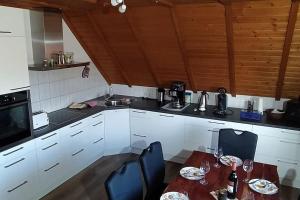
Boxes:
[105,109,131,155]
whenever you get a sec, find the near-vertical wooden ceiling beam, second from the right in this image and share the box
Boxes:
[223,0,236,97]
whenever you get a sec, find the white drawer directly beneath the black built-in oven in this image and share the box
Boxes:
[0,140,35,164]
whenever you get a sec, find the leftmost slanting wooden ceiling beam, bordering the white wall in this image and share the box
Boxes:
[62,12,112,85]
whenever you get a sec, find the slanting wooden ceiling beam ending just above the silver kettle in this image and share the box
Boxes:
[169,8,197,92]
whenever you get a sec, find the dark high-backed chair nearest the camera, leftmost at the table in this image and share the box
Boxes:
[105,161,143,200]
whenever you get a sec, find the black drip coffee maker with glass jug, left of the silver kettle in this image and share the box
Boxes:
[169,81,185,109]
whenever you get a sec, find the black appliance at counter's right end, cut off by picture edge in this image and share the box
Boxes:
[284,96,300,124]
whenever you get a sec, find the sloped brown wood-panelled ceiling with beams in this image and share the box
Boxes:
[0,0,300,99]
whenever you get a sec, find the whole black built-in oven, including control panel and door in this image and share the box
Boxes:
[0,91,32,149]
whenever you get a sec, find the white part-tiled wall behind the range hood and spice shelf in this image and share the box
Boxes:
[26,18,108,112]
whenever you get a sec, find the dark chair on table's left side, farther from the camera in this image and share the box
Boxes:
[139,142,167,200]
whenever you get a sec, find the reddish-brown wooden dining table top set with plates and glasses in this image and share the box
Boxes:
[165,151,279,200]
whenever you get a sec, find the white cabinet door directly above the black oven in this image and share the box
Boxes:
[0,37,29,94]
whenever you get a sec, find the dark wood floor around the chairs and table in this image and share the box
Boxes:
[42,154,300,200]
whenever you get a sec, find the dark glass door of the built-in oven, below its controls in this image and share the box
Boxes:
[0,101,32,148]
